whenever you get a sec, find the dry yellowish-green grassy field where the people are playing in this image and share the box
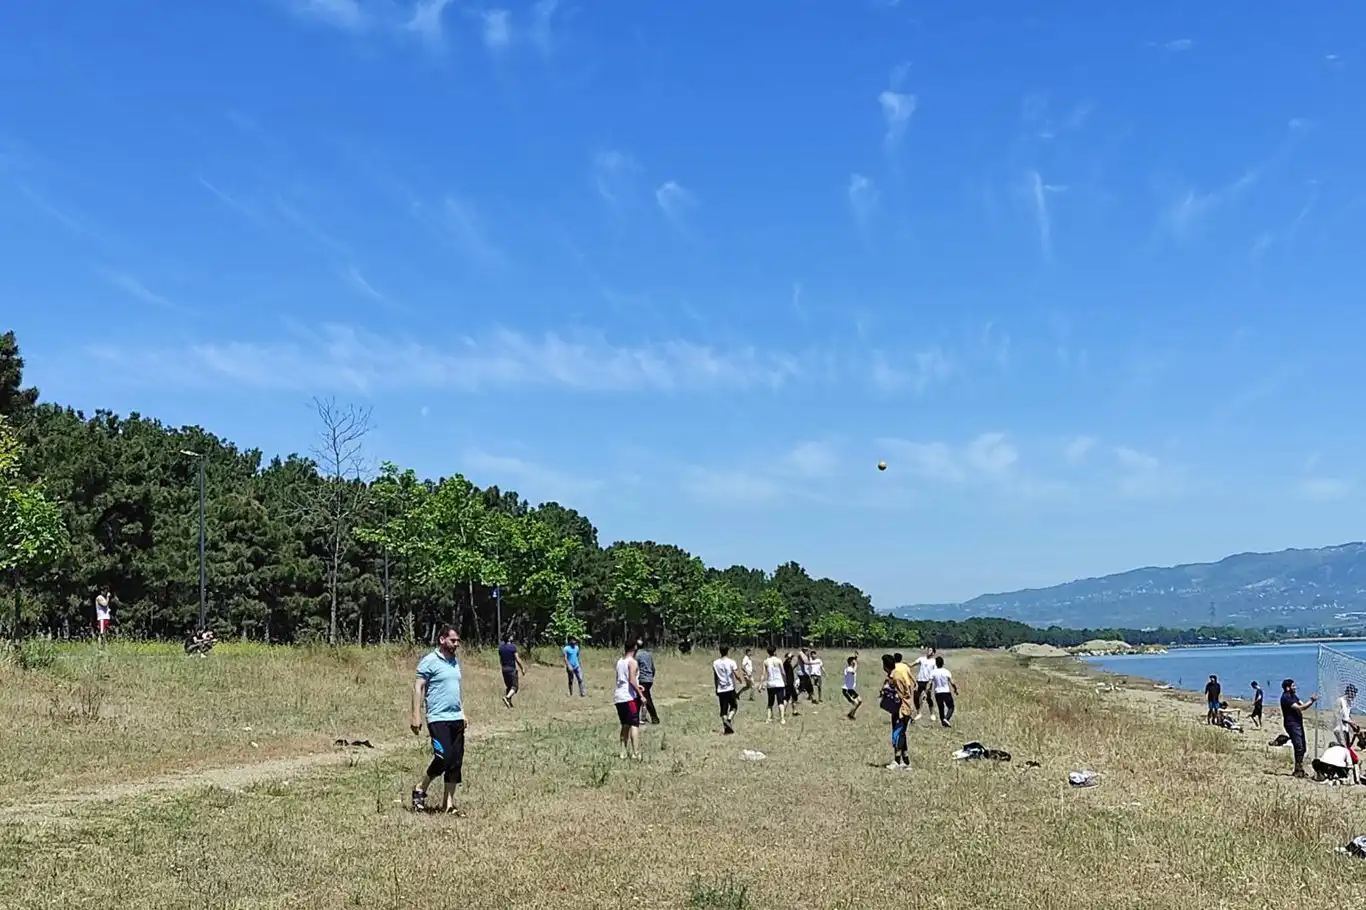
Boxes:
[0,646,1366,910]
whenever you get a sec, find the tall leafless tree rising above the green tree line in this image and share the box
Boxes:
[303,398,374,645]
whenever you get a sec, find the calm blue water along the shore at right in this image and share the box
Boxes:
[1086,639,1366,702]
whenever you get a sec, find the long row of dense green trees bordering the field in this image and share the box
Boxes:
[0,332,1273,648]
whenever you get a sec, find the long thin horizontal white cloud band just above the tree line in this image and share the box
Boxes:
[92,325,803,392]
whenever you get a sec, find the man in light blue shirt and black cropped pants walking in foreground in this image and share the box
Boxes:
[410,626,464,816]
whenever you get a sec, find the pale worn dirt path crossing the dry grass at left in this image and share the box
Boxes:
[0,695,694,825]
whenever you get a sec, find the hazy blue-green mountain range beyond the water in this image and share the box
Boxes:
[892,542,1366,629]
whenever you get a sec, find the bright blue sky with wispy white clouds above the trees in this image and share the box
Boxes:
[0,0,1366,608]
